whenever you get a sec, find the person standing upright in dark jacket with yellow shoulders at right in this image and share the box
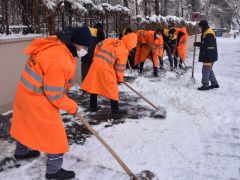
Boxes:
[194,20,219,91]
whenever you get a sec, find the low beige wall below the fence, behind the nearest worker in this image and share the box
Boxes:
[0,37,81,113]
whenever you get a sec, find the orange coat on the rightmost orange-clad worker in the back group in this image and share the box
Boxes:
[177,27,188,61]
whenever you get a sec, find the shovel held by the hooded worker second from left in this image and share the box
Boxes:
[123,82,166,118]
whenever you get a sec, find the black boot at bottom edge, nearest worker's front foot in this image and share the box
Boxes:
[45,168,75,180]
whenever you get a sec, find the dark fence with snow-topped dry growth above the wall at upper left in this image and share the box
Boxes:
[0,0,131,36]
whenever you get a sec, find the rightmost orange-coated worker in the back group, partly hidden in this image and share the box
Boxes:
[176,23,188,68]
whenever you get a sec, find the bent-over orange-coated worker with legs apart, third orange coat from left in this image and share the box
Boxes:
[135,29,163,77]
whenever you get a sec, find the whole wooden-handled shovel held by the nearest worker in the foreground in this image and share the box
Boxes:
[76,113,154,180]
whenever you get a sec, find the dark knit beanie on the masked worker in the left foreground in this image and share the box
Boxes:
[71,27,92,47]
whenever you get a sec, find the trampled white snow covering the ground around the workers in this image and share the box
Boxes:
[0,38,240,180]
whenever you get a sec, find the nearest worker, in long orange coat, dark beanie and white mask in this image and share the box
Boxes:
[10,27,92,179]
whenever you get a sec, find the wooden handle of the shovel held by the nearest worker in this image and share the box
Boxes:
[76,113,135,178]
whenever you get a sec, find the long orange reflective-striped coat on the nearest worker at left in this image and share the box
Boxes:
[10,36,77,154]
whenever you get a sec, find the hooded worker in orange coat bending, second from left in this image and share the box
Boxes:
[81,33,137,114]
